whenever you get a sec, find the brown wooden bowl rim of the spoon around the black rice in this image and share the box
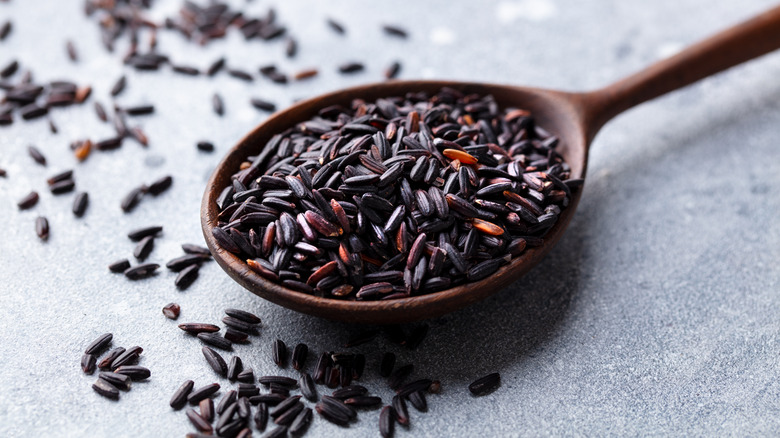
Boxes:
[202,81,587,324]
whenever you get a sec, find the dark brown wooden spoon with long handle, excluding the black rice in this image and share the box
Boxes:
[201,7,780,324]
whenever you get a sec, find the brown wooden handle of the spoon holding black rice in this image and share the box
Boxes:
[582,6,780,139]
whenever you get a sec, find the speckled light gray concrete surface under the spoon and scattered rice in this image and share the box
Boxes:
[0,0,780,437]
